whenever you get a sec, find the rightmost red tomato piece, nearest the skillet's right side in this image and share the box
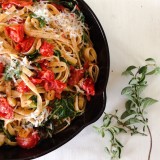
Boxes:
[80,78,95,96]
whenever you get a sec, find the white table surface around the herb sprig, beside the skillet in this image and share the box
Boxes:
[36,0,160,160]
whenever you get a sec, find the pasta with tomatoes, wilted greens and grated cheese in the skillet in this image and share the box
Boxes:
[0,0,99,149]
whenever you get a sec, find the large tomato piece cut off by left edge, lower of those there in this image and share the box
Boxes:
[0,98,14,119]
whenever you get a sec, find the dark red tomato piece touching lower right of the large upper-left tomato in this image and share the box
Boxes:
[18,37,35,52]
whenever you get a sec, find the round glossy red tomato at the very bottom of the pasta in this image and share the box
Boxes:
[16,131,40,149]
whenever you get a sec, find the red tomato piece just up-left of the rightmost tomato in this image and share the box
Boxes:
[68,67,84,86]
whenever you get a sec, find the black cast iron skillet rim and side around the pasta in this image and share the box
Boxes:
[0,0,110,160]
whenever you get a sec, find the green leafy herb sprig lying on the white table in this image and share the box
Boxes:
[94,58,160,160]
